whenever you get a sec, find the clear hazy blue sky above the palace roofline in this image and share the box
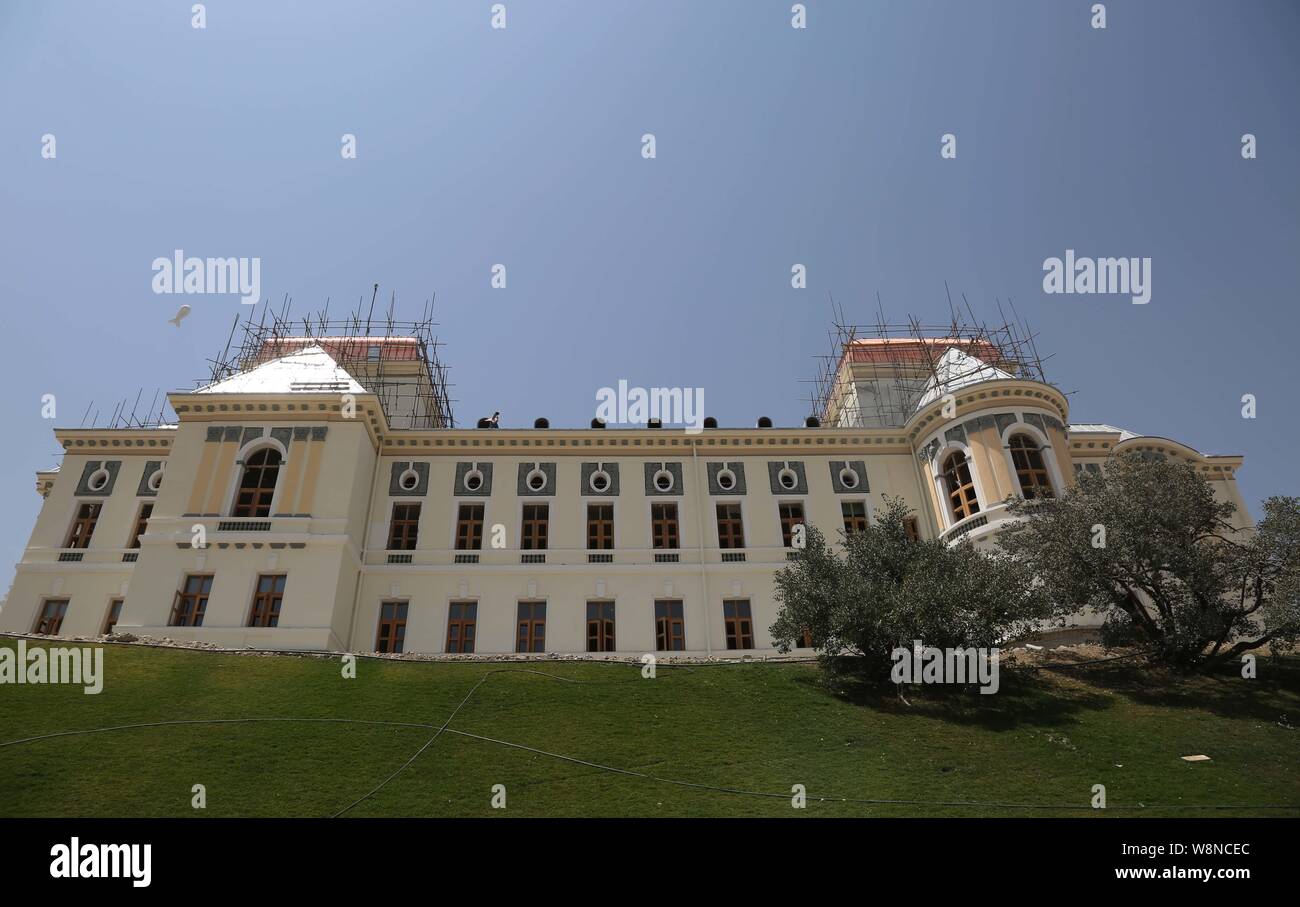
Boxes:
[0,0,1300,576]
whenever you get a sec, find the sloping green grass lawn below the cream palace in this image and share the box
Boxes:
[0,639,1300,816]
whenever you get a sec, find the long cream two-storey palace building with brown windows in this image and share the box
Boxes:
[0,320,1248,656]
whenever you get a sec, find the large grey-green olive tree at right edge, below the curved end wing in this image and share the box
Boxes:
[1000,454,1300,671]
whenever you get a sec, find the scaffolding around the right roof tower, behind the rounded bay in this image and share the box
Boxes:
[810,283,1050,429]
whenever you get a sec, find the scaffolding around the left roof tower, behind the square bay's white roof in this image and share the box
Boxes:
[205,283,456,429]
